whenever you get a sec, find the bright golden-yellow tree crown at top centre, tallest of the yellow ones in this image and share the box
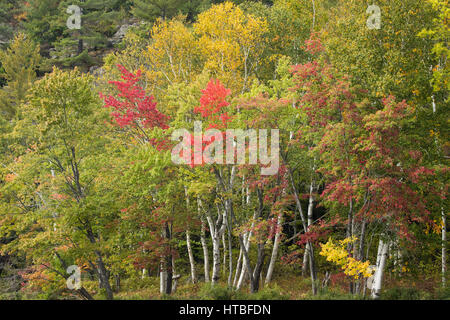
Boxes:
[194,2,268,91]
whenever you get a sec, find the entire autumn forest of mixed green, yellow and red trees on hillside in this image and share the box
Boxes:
[0,0,450,299]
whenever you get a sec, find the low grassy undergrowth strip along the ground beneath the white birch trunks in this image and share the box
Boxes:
[107,274,450,300]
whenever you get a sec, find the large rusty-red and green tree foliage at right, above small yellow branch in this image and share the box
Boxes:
[291,38,437,245]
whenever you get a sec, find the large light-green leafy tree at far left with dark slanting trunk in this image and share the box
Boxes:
[2,69,116,298]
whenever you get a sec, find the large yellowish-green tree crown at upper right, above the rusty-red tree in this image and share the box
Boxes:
[325,0,435,107]
